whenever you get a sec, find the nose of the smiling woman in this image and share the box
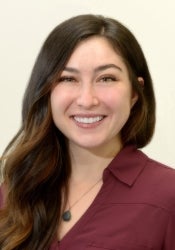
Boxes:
[77,84,99,109]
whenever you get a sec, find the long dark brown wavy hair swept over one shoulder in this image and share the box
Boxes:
[0,15,155,250]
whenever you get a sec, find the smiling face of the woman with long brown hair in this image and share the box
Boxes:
[51,36,137,152]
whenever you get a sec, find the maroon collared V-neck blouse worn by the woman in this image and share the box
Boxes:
[0,146,175,250]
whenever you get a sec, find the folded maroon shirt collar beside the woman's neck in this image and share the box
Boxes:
[107,145,148,186]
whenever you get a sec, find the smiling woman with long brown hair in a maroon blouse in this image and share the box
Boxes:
[0,15,175,250]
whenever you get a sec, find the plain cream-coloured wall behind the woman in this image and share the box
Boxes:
[0,0,175,167]
